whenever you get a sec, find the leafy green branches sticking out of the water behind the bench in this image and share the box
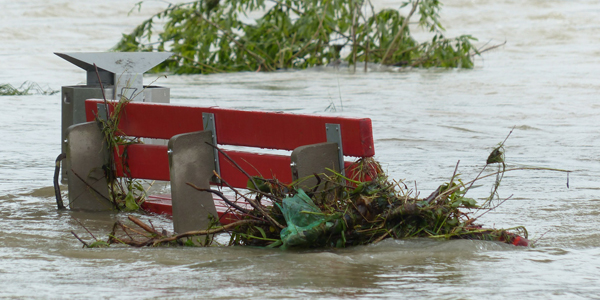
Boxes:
[114,0,479,74]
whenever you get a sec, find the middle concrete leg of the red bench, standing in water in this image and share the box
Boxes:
[169,131,218,233]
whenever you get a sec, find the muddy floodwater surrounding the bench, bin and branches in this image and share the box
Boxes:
[0,0,600,299]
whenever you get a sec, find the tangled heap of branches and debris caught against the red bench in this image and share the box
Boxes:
[72,132,568,249]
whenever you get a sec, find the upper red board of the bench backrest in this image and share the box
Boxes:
[86,100,375,157]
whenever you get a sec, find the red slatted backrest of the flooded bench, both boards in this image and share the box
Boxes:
[85,100,375,187]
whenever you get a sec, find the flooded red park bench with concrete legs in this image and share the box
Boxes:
[66,99,375,232]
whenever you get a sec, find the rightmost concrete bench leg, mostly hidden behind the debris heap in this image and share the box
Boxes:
[291,142,340,190]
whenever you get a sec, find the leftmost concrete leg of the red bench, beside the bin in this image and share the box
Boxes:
[66,122,114,211]
